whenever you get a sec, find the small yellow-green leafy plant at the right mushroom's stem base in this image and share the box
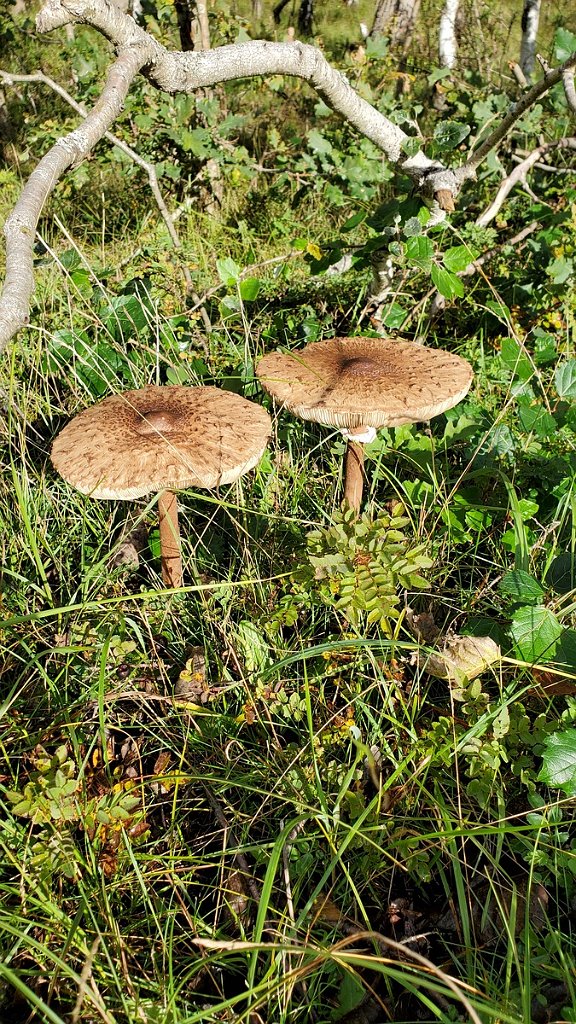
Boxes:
[307,502,434,635]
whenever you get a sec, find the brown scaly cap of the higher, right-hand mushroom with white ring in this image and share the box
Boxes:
[256,338,472,430]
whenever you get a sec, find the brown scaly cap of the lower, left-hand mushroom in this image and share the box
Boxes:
[51,384,272,500]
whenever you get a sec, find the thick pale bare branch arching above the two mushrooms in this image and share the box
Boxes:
[0,0,576,360]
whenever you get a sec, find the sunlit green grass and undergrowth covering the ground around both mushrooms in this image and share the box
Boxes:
[0,0,576,1024]
